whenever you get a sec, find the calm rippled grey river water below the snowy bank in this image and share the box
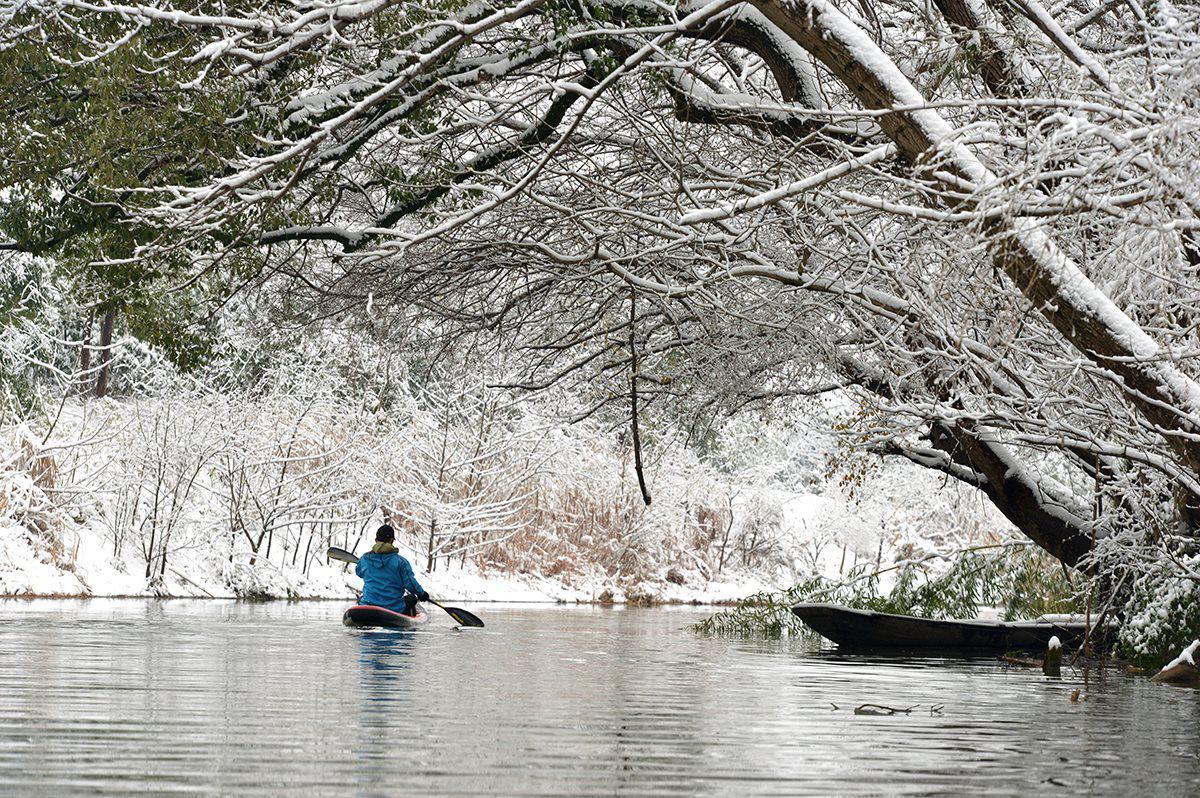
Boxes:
[0,600,1200,796]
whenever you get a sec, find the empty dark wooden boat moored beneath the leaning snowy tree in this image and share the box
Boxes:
[792,604,1109,652]
